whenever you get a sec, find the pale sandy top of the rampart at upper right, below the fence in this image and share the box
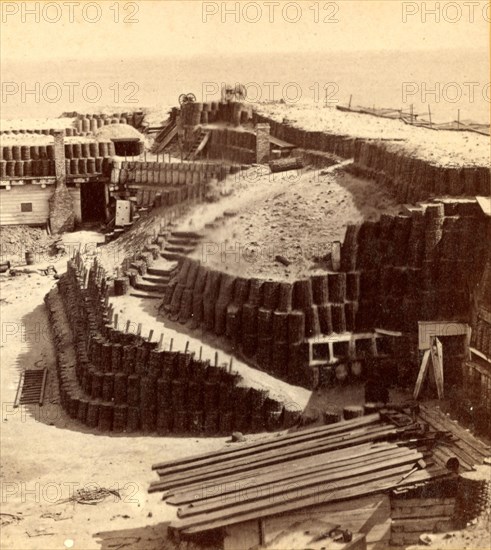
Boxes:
[257,103,489,166]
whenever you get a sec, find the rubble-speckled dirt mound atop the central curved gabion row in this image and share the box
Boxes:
[188,162,401,280]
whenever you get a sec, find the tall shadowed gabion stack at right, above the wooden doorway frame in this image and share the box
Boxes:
[342,203,485,331]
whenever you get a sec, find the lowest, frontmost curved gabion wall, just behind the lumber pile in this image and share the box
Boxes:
[52,263,302,435]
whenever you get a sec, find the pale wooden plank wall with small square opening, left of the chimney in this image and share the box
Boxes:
[0,185,54,225]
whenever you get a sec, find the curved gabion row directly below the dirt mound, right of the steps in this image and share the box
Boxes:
[164,259,366,387]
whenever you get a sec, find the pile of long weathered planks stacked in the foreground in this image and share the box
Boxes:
[149,413,448,534]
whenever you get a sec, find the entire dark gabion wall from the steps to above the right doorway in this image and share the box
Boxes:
[164,200,487,396]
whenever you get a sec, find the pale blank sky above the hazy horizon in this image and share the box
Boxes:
[0,0,491,62]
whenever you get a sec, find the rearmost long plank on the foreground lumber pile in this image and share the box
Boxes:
[152,413,380,470]
